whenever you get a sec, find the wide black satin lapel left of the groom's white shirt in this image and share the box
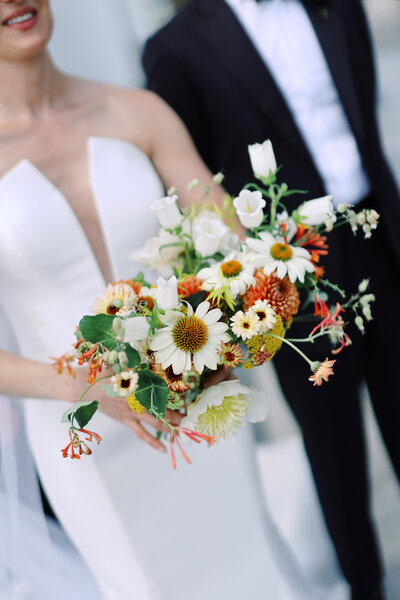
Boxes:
[189,0,309,161]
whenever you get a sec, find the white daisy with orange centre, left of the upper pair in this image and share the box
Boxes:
[197,252,255,300]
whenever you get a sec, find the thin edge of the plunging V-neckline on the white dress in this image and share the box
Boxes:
[0,136,152,284]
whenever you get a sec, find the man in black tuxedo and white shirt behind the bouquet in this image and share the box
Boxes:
[144,0,400,600]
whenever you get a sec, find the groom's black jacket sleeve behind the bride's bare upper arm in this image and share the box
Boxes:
[143,36,213,168]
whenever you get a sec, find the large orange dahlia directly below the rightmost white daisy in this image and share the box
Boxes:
[243,270,300,321]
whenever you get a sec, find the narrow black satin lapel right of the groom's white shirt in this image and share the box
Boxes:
[305,3,363,141]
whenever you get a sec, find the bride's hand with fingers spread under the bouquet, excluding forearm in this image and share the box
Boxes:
[70,369,182,453]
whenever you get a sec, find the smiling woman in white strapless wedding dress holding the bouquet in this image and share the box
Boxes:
[0,0,313,600]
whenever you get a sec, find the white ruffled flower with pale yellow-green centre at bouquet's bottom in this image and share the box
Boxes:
[181,380,268,441]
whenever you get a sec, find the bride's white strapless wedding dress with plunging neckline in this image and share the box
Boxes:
[0,138,314,600]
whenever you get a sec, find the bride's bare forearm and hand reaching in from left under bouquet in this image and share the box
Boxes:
[0,350,172,452]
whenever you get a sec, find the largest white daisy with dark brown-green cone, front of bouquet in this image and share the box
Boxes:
[149,302,230,375]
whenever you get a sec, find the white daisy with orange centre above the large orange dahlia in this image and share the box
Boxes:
[246,231,315,283]
